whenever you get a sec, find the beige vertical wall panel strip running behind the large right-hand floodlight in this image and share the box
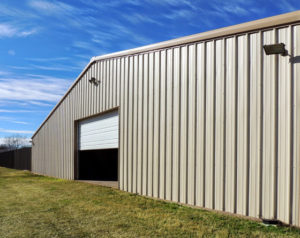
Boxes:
[262,30,277,218]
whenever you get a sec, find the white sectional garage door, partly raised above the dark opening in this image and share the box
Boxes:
[78,112,119,150]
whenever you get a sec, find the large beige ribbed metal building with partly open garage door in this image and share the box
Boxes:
[32,11,300,226]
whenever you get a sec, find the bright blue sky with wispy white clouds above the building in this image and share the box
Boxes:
[0,0,300,143]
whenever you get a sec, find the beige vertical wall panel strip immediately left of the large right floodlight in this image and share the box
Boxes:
[248,33,263,217]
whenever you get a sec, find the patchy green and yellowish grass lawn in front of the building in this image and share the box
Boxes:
[0,167,300,238]
